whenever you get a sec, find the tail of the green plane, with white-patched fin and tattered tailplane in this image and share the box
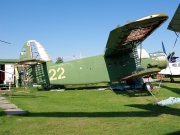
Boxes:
[16,40,53,87]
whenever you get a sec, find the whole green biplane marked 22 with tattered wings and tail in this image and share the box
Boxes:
[18,13,168,89]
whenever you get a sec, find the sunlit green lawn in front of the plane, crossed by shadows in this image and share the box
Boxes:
[0,83,180,135]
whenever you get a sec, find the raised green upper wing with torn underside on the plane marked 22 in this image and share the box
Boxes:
[105,14,168,56]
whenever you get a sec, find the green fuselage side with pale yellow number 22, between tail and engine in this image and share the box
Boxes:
[47,54,136,84]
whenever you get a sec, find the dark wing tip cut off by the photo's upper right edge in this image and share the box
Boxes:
[168,4,180,32]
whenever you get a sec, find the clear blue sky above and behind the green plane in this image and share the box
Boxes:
[0,0,180,61]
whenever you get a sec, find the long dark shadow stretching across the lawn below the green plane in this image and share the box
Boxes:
[24,104,180,118]
